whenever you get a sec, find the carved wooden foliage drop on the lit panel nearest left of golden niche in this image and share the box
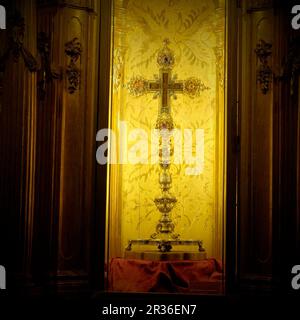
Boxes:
[65,38,82,94]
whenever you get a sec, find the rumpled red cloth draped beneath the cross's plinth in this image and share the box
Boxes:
[109,258,223,293]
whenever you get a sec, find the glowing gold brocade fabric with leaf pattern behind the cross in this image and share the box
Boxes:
[107,0,225,258]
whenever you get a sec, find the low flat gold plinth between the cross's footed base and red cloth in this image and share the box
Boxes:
[125,250,206,261]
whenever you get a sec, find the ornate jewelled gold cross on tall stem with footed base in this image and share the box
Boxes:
[126,39,209,252]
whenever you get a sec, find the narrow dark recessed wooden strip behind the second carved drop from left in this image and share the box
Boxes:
[33,7,63,282]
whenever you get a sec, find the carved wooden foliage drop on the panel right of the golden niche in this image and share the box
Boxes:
[255,40,273,94]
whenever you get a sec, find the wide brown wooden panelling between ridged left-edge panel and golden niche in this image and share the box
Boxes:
[34,1,98,290]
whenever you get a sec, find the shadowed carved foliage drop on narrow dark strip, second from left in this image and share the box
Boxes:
[38,32,60,100]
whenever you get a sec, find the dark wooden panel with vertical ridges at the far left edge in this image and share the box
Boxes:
[0,0,36,286]
